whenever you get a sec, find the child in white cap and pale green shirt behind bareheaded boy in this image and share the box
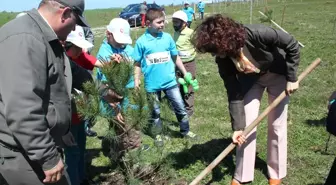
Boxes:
[173,10,196,117]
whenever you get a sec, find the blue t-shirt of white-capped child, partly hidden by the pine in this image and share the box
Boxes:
[97,39,134,88]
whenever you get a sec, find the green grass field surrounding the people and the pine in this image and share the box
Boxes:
[0,0,336,185]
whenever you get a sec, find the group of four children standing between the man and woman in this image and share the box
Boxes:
[58,6,199,184]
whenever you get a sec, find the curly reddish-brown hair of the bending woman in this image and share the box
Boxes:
[192,14,245,57]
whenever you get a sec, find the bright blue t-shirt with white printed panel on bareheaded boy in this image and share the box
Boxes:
[133,30,178,92]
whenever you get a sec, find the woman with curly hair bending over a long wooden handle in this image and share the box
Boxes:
[193,14,300,185]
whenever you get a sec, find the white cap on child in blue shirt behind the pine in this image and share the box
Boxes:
[106,18,132,44]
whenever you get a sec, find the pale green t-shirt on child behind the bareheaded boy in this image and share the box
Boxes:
[174,27,196,62]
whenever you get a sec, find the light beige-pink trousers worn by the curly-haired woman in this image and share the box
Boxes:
[234,73,289,182]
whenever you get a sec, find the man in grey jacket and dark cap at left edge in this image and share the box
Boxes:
[0,0,87,185]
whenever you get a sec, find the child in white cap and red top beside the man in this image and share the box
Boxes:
[64,25,102,184]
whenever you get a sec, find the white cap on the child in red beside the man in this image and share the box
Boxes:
[66,25,93,49]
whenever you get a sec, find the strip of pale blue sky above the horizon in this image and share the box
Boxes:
[0,0,200,12]
